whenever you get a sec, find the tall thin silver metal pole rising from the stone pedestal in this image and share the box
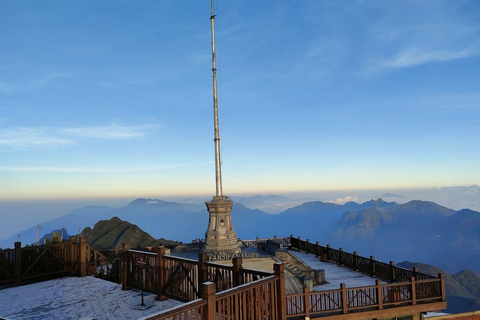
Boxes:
[210,0,222,197]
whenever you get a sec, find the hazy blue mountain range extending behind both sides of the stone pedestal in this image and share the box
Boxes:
[0,196,480,273]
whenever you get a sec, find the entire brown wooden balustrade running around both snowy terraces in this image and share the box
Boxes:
[0,237,445,320]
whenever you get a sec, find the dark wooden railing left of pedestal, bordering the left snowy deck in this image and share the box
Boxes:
[123,245,273,301]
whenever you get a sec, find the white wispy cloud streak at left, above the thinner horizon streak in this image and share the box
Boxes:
[0,123,159,151]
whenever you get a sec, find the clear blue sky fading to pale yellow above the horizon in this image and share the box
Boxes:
[0,0,480,200]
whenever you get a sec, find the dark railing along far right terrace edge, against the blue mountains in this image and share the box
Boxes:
[290,236,435,282]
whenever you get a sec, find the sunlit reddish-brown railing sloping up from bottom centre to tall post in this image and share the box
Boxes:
[141,264,286,320]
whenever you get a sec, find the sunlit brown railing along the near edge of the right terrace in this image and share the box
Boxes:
[286,275,445,318]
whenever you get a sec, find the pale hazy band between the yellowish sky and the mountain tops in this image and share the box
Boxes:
[0,185,480,239]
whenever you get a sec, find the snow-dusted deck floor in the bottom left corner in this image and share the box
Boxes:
[0,277,181,320]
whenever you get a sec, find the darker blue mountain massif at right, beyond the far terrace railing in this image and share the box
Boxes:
[330,201,480,273]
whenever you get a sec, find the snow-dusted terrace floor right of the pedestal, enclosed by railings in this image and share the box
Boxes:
[290,250,386,291]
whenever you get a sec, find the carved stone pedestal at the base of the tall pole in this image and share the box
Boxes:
[204,196,241,255]
